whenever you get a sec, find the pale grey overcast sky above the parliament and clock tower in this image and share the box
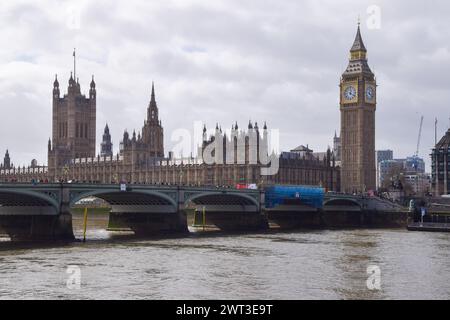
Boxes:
[0,0,450,170]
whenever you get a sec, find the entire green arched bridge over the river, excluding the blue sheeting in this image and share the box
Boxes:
[0,183,406,240]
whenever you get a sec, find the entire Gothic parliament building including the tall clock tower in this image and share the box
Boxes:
[0,26,376,192]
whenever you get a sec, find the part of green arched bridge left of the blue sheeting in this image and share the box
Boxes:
[0,183,267,240]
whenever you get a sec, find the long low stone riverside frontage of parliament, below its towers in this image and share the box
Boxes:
[0,149,340,191]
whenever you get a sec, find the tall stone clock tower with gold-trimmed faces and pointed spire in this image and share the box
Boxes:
[340,23,377,193]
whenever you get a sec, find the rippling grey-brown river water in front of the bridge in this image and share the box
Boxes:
[0,215,450,299]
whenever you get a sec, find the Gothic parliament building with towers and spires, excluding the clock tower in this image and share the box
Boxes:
[0,58,340,191]
